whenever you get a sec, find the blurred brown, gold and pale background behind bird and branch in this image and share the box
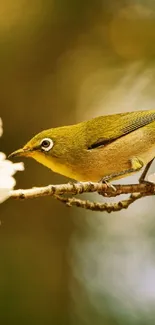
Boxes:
[0,0,155,325]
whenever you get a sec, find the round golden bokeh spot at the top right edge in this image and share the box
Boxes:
[109,5,155,60]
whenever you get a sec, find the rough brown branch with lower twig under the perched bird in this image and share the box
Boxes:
[10,182,155,212]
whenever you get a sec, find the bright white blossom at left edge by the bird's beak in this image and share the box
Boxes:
[0,118,24,203]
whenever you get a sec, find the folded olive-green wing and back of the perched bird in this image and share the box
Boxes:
[87,110,155,149]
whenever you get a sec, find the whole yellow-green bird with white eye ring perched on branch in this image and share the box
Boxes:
[10,110,155,182]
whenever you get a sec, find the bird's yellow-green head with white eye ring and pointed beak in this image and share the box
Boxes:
[9,126,81,176]
